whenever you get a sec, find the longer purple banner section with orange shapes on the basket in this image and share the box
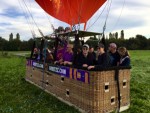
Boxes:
[48,65,90,83]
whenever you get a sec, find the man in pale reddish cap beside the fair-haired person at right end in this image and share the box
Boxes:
[109,43,120,66]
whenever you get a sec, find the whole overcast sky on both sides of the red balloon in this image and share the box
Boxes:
[0,0,150,40]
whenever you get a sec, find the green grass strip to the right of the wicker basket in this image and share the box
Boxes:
[124,50,150,113]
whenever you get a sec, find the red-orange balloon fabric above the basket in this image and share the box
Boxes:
[35,0,106,25]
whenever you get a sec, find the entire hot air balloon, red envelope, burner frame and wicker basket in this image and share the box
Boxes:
[26,0,131,113]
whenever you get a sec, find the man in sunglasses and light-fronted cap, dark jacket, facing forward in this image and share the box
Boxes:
[76,44,94,68]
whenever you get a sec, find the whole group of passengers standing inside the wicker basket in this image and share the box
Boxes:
[33,43,130,70]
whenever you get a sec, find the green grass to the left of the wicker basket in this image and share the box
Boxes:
[0,57,78,113]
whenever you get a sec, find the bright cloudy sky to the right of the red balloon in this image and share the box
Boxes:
[86,0,150,38]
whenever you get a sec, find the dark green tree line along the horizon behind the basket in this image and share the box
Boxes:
[0,30,150,51]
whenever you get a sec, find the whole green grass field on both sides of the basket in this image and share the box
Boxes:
[0,51,150,113]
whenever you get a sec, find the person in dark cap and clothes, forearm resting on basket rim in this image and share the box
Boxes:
[88,43,110,70]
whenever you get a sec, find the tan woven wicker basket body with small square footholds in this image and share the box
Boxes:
[26,59,130,113]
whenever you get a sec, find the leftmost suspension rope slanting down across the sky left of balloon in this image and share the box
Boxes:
[18,0,36,38]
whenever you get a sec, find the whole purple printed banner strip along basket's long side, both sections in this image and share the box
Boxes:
[26,59,90,83]
